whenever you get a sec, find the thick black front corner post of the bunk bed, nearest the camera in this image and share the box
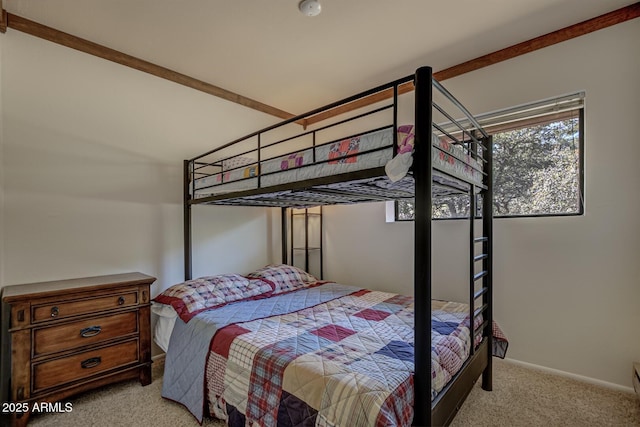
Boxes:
[413,67,433,426]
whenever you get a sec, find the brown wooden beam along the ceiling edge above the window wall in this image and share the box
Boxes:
[306,2,640,126]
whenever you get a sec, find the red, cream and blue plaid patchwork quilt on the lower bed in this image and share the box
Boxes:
[201,290,504,426]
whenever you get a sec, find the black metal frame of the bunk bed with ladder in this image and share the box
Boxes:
[184,67,493,425]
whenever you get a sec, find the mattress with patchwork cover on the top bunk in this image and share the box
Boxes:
[190,125,482,198]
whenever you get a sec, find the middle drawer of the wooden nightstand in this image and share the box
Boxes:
[33,311,138,357]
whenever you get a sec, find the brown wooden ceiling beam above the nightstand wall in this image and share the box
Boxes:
[0,12,294,119]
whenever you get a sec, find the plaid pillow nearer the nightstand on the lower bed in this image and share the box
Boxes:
[153,274,273,322]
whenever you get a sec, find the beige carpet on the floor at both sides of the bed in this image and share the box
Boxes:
[29,359,640,427]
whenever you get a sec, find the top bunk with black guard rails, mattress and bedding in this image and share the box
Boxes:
[185,72,487,208]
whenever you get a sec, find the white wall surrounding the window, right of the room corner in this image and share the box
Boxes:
[325,19,640,387]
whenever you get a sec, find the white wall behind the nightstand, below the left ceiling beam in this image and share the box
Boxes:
[0,29,279,294]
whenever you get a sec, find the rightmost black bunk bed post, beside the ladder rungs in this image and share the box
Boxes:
[482,135,493,391]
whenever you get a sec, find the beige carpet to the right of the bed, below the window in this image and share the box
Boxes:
[451,358,640,427]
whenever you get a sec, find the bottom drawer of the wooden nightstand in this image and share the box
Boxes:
[33,339,138,393]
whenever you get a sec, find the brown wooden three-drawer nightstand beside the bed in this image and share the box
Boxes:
[1,273,156,426]
